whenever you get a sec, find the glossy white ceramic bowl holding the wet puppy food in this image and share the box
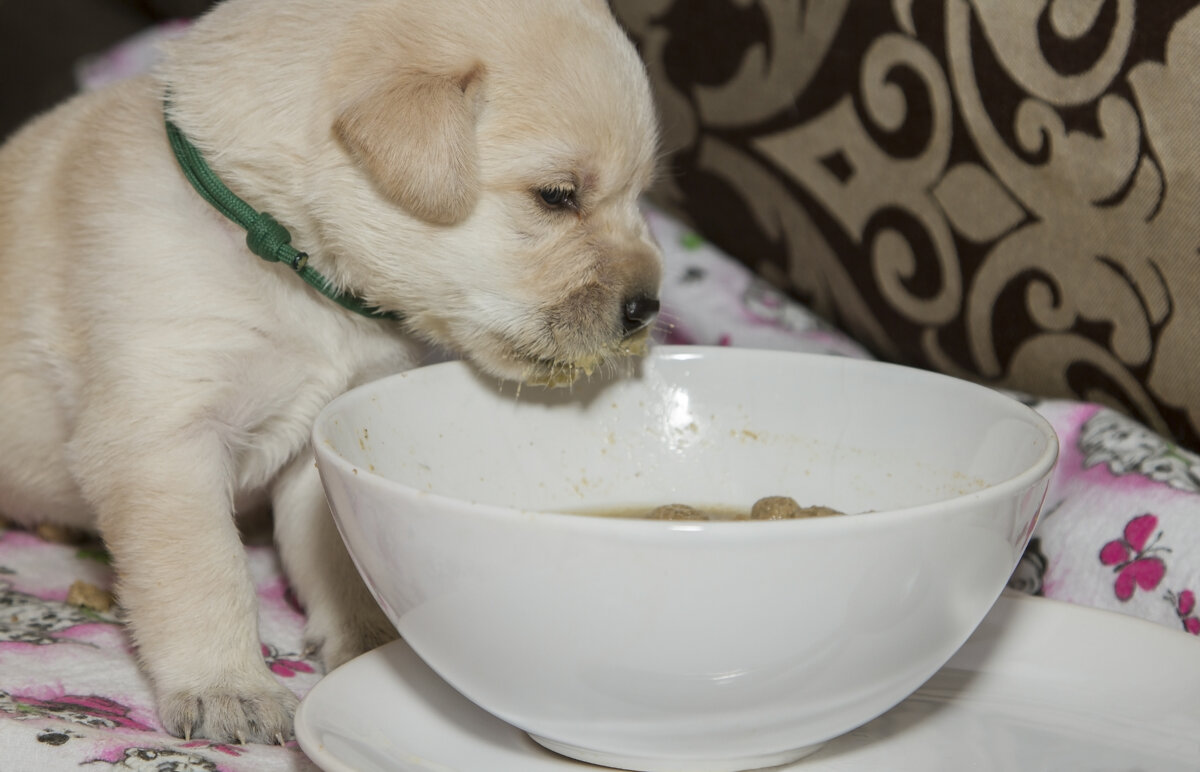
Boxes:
[314,347,1057,772]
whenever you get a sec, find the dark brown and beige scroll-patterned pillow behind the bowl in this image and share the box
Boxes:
[612,0,1200,448]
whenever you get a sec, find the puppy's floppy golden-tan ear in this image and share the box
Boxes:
[334,65,484,225]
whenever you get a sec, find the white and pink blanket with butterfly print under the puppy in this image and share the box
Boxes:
[0,25,1200,772]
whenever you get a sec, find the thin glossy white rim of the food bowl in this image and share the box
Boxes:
[311,345,1060,538]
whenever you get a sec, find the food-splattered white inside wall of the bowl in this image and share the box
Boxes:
[323,348,1052,513]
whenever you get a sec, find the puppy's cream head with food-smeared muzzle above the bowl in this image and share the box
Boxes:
[326,0,661,383]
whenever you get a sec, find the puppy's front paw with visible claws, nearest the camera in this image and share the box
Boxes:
[158,684,298,744]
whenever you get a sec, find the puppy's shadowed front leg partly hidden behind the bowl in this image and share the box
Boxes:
[271,453,397,671]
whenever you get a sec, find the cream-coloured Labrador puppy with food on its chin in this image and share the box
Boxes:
[0,0,660,742]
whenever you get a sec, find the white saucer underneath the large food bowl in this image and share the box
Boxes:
[295,594,1200,772]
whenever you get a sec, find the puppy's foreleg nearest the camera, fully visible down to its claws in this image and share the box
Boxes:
[78,434,296,742]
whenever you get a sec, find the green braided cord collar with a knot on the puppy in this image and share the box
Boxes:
[164,105,400,319]
